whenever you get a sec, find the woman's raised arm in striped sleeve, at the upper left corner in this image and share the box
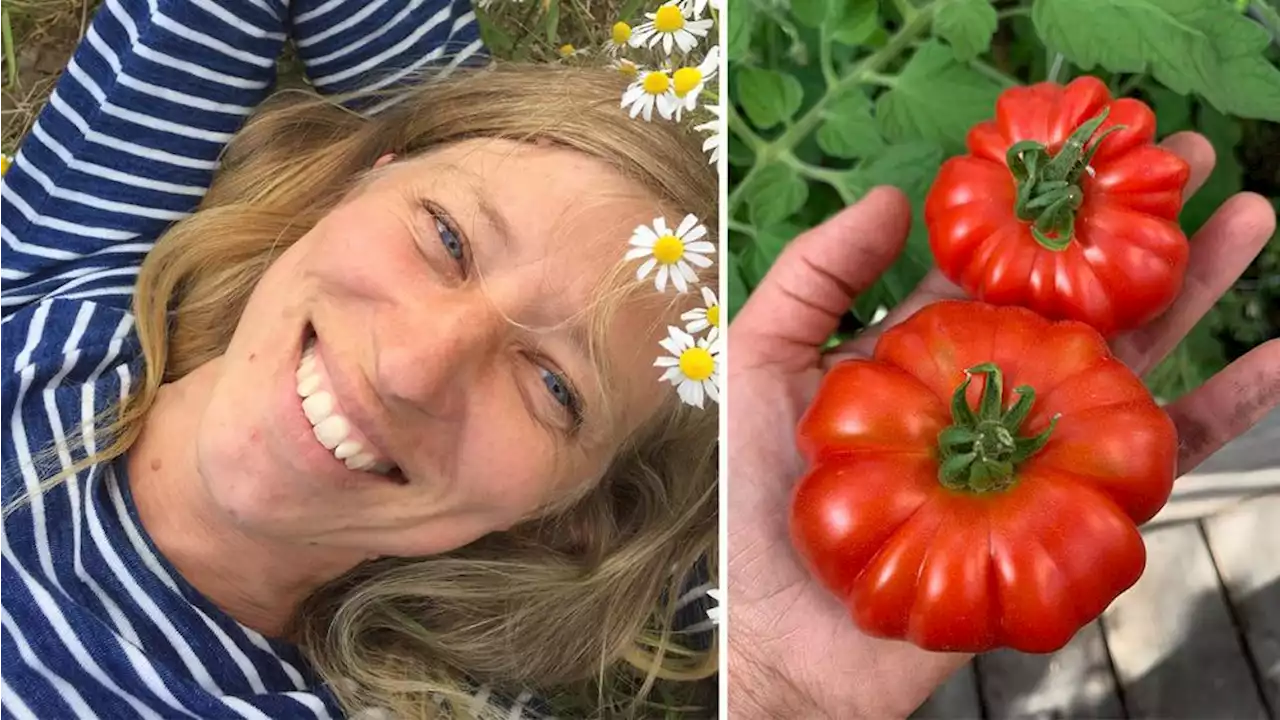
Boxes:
[0,0,288,318]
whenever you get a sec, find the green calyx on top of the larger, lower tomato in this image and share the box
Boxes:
[938,363,1059,493]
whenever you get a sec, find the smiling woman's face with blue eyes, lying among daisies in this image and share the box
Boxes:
[196,140,666,555]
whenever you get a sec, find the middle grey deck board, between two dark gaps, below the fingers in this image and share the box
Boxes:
[1102,523,1266,720]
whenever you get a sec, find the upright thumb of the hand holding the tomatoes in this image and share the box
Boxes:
[730,187,911,370]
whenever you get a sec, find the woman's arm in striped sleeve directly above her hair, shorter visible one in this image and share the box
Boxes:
[289,0,486,105]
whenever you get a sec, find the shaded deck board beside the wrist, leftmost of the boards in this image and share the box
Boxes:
[975,623,1124,720]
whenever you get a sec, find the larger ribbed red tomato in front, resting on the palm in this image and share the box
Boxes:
[791,301,1178,652]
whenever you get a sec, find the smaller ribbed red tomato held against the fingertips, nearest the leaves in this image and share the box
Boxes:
[924,77,1190,337]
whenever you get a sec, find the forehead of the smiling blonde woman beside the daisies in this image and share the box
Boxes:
[389,140,692,427]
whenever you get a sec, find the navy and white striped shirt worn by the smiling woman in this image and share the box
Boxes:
[0,0,524,720]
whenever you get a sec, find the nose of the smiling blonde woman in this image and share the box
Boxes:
[376,291,509,418]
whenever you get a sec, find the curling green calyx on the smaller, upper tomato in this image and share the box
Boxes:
[1005,108,1124,251]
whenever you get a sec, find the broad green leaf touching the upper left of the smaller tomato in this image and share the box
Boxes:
[876,40,1001,151]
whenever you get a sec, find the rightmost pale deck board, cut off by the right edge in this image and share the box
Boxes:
[1204,489,1280,715]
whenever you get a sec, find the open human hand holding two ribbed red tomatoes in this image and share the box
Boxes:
[728,133,1280,717]
